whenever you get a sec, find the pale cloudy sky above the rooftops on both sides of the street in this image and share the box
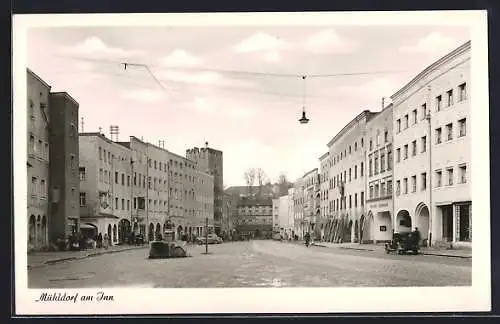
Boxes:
[28,26,470,186]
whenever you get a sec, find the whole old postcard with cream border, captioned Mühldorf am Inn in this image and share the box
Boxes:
[13,11,491,315]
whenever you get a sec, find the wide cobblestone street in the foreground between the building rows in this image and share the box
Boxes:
[28,241,472,288]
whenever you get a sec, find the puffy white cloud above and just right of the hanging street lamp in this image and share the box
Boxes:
[304,29,359,54]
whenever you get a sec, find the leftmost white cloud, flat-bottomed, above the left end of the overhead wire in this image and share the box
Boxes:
[63,36,144,59]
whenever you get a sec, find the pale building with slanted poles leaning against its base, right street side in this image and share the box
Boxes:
[325,110,376,242]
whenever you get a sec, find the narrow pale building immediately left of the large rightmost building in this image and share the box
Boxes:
[360,104,393,242]
